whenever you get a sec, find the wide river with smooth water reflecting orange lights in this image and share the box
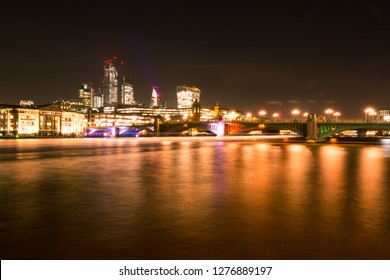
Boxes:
[0,137,390,260]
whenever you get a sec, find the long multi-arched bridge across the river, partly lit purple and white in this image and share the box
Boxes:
[86,114,390,142]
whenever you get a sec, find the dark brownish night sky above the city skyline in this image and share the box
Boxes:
[0,0,390,118]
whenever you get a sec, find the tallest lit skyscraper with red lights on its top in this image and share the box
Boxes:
[103,57,119,106]
